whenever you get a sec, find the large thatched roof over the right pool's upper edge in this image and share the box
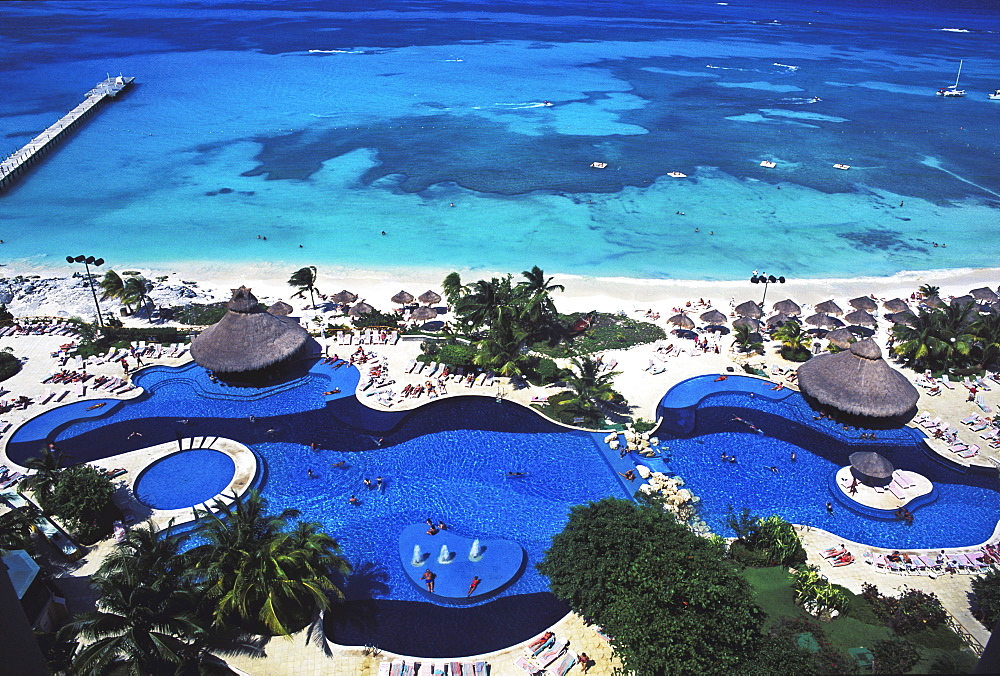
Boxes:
[798,338,920,418]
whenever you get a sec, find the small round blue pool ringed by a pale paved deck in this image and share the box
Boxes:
[135,448,236,509]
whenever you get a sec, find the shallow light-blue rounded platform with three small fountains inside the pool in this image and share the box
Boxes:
[399,524,527,603]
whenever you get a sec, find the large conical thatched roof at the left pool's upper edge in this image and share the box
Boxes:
[191,286,309,373]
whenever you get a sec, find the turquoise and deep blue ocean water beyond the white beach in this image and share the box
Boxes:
[0,0,1000,280]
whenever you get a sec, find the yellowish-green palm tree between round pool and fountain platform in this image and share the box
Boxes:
[190,491,350,636]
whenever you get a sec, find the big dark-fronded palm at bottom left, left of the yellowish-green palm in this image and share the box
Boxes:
[62,525,234,674]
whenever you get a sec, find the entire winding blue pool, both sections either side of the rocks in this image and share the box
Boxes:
[8,361,1000,657]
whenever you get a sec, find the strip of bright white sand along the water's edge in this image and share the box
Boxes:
[3,261,1000,316]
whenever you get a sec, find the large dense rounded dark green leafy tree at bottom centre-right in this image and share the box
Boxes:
[538,498,764,676]
